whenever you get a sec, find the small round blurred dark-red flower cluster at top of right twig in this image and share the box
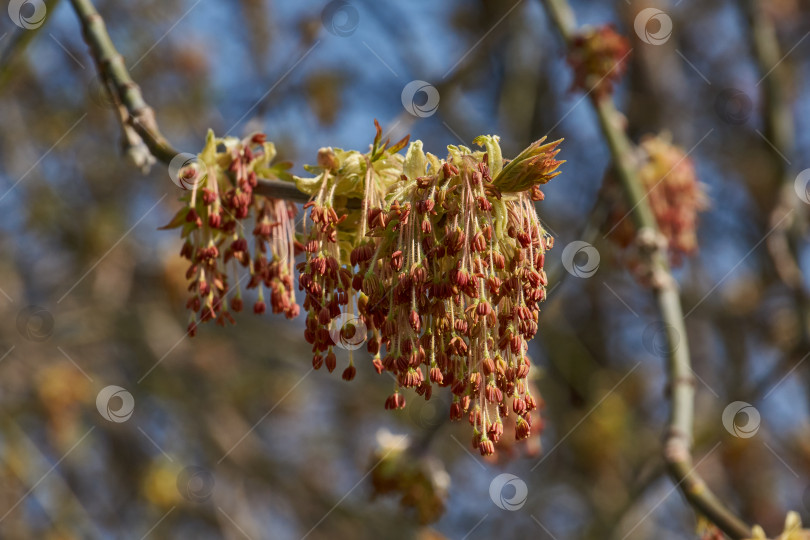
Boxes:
[568,24,630,97]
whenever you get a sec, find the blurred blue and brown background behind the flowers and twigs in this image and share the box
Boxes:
[0,0,810,539]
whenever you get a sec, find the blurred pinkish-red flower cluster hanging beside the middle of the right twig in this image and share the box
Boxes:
[608,135,709,265]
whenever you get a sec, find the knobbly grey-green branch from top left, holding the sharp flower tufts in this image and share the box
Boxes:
[70,0,309,202]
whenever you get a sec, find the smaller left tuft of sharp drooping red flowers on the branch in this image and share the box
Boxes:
[163,132,299,336]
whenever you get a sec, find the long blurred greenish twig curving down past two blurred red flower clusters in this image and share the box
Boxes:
[544,0,751,539]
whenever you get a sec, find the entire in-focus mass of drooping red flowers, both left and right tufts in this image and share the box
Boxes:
[167,124,561,455]
